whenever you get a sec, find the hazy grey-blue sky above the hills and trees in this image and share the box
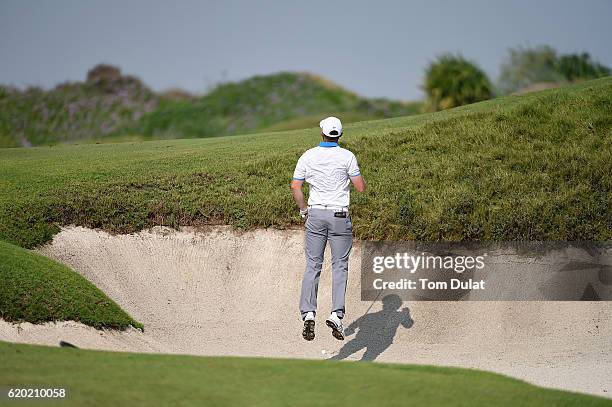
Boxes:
[0,0,612,99]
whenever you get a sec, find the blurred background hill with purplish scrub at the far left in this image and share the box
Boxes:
[0,76,158,147]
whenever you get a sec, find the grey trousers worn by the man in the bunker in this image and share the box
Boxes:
[300,209,353,319]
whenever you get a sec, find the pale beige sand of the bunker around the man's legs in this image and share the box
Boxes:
[0,227,612,396]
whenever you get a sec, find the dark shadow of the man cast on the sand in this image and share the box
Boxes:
[330,294,414,361]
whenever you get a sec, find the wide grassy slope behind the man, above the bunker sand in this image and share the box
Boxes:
[0,78,612,247]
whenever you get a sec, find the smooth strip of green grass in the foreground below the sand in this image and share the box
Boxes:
[0,342,612,407]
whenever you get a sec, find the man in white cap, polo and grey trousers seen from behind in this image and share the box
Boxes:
[291,117,366,341]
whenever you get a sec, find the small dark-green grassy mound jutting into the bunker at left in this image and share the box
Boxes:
[0,241,142,329]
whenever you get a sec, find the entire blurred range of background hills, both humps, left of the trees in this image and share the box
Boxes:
[0,71,420,147]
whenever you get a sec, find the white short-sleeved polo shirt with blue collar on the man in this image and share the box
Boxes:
[293,141,360,207]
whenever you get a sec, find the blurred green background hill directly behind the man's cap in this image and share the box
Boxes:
[126,72,420,138]
